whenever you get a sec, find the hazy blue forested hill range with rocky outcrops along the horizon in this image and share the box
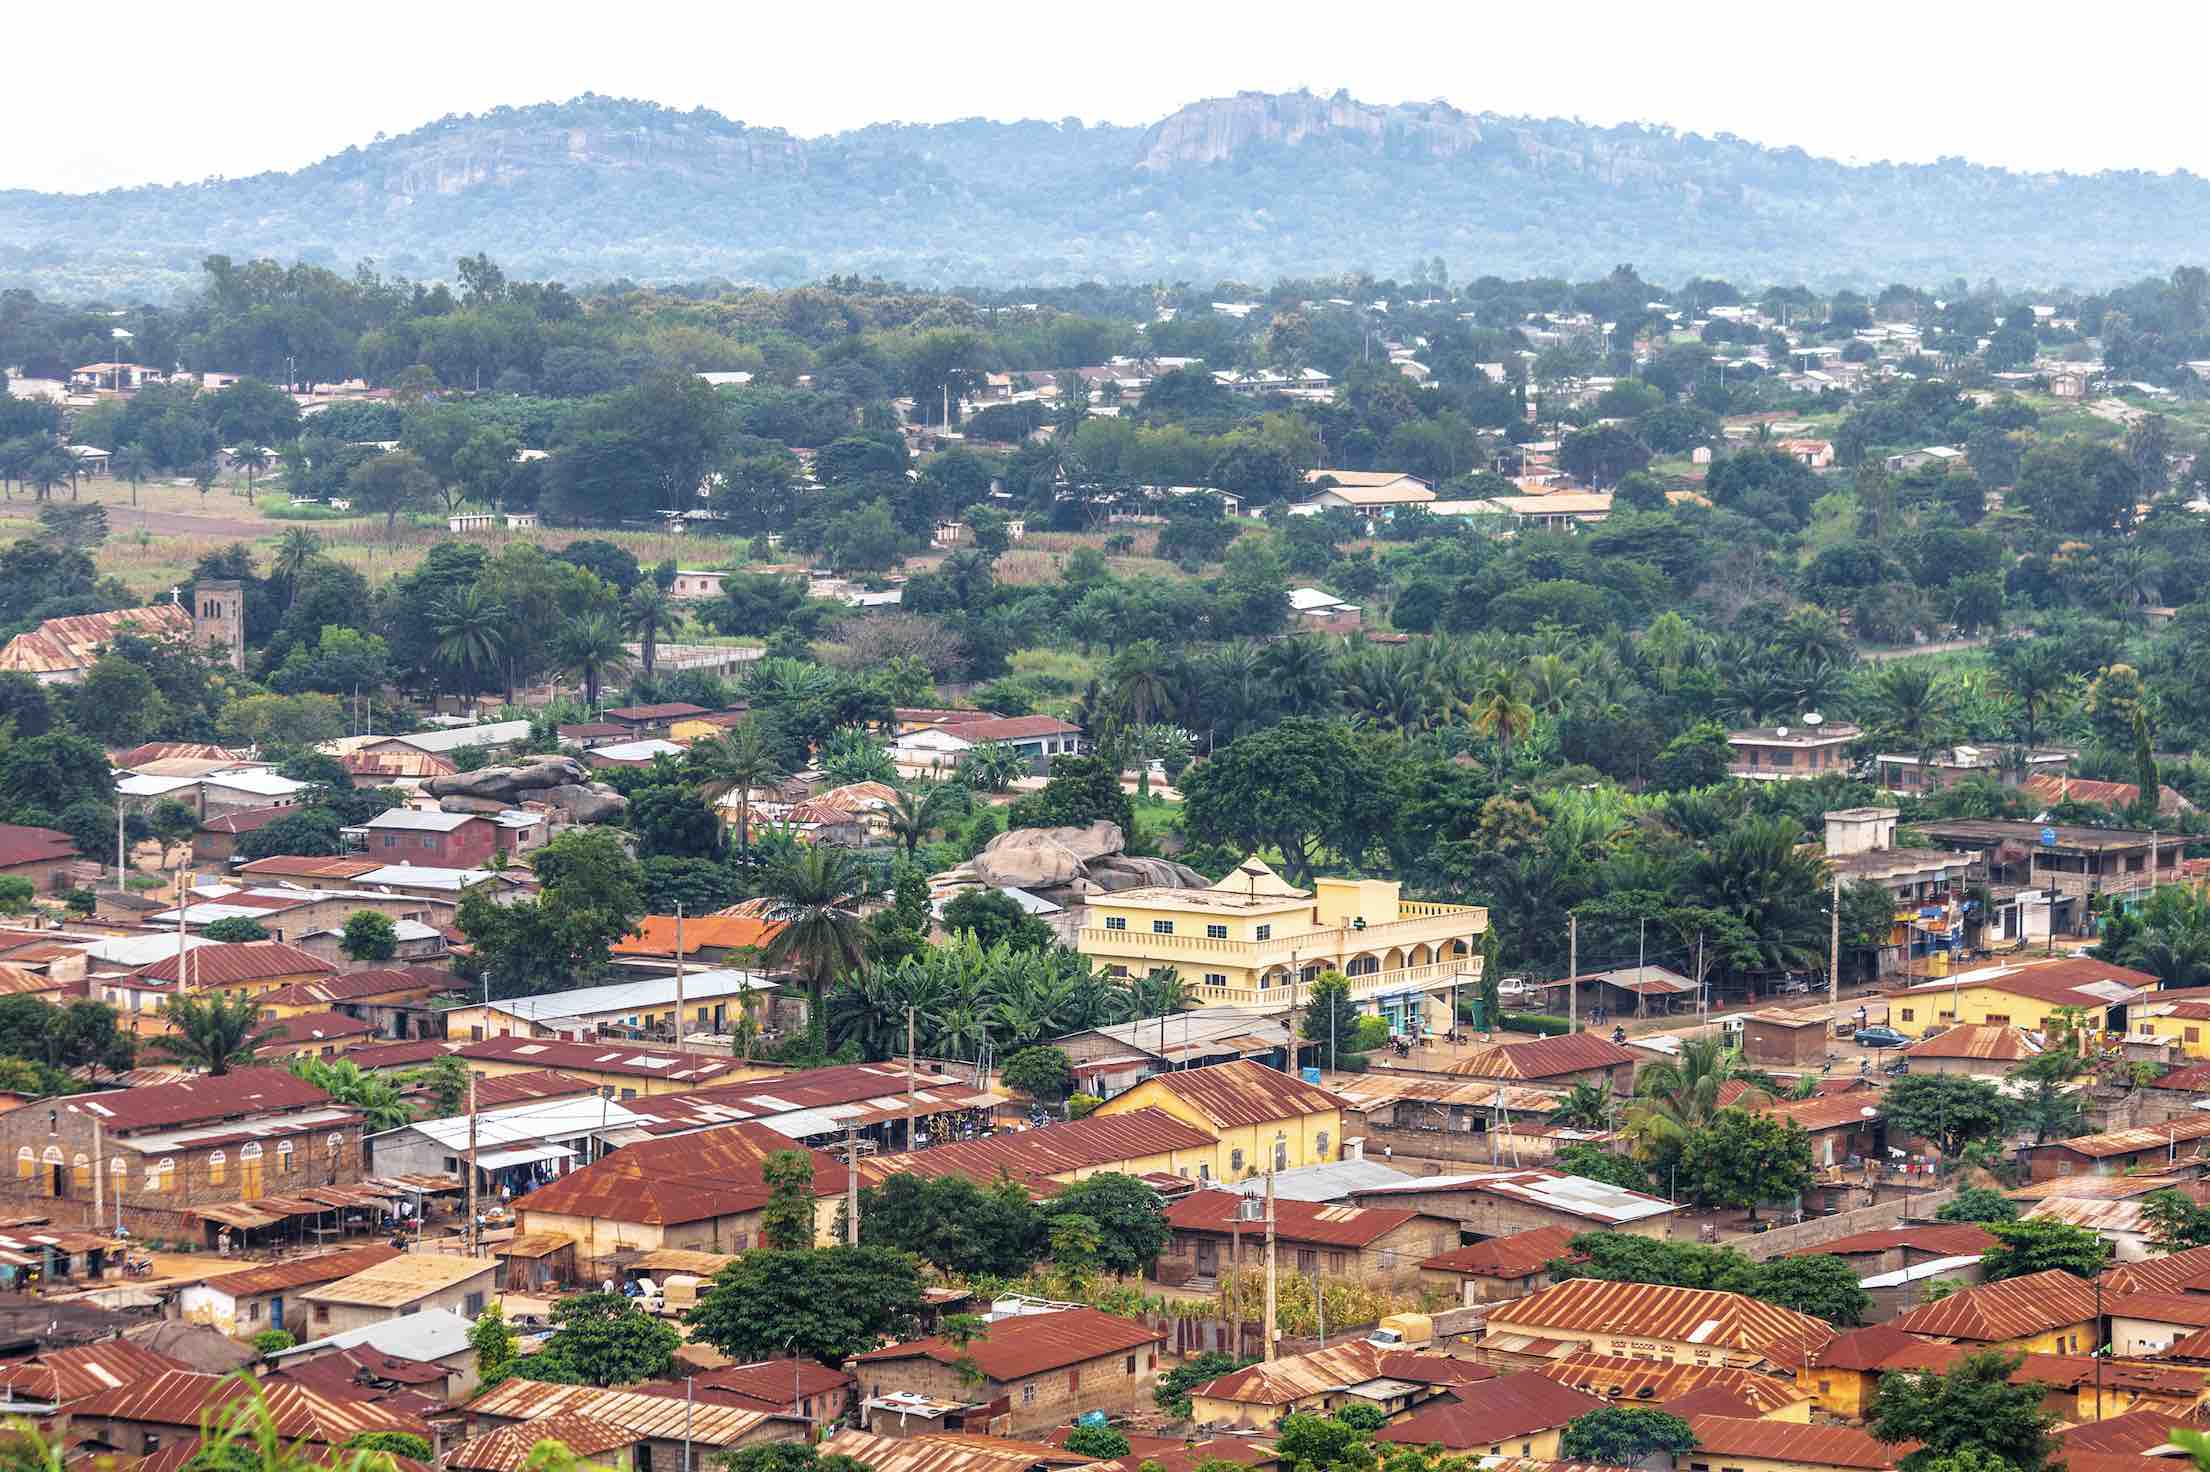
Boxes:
[0,93,2210,296]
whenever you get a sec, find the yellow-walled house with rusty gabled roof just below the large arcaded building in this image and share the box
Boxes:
[1096,1059,1346,1180]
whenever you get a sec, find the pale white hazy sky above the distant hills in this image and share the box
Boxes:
[17,0,2210,190]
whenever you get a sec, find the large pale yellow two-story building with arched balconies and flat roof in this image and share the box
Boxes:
[1076,860,1490,1032]
